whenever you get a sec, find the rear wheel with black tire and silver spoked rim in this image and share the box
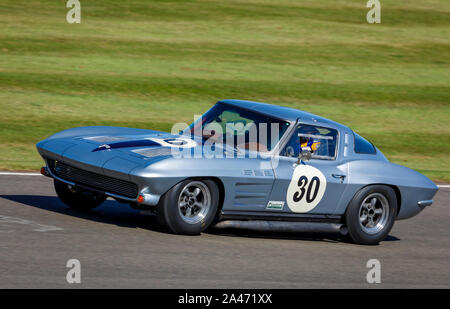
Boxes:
[345,185,397,245]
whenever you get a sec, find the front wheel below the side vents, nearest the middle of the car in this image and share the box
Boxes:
[156,179,219,235]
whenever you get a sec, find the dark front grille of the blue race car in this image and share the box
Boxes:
[47,159,138,198]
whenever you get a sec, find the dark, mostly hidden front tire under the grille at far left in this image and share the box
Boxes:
[53,179,106,210]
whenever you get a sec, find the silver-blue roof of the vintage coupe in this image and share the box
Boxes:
[218,100,348,129]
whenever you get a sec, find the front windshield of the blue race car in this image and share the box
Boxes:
[183,103,290,152]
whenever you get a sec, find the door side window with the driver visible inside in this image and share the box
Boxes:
[280,125,337,160]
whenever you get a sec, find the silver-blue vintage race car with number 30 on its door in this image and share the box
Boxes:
[37,100,438,245]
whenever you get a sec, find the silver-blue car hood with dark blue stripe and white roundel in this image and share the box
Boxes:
[36,127,201,176]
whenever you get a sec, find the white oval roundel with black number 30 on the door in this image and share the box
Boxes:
[286,164,327,212]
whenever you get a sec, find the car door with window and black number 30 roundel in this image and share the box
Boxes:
[267,122,348,215]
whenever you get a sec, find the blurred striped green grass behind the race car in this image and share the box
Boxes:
[0,0,450,181]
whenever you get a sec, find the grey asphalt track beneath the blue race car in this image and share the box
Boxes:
[0,175,450,289]
